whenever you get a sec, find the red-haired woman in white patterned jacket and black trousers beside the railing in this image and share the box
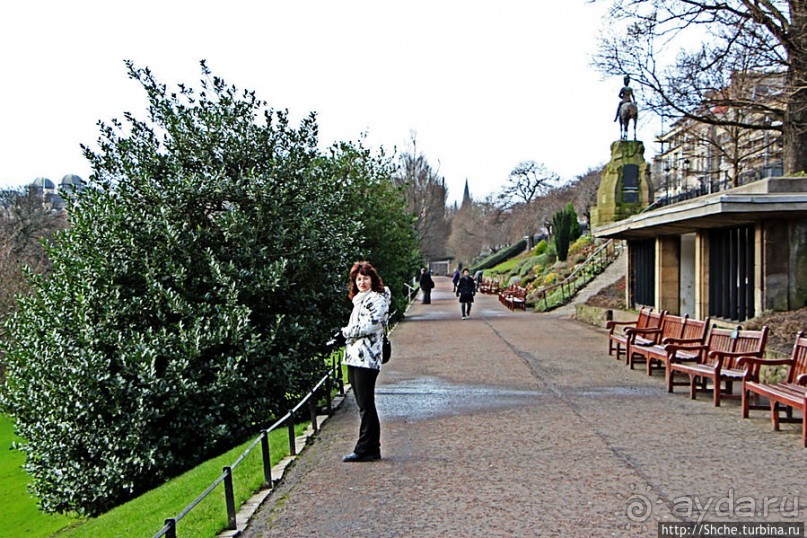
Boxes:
[335,262,390,462]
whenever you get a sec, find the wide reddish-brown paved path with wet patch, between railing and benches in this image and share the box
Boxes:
[244,278,807,538]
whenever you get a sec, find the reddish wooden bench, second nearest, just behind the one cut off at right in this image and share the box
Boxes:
[667,326,768,406]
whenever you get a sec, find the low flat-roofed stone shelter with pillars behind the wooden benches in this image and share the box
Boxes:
[594,177,807,321]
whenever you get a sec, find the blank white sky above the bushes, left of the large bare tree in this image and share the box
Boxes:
[0,0,657,200]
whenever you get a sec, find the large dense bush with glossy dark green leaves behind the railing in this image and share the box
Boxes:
[0,63,417,514]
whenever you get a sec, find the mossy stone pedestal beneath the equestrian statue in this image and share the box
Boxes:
[590,140,653,230]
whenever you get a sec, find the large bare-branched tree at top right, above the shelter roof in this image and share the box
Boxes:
[592,0,807,173]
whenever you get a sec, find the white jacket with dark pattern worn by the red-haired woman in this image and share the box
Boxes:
[342,286,391,370]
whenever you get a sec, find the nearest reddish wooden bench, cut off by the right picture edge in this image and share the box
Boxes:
[738,332,807,448]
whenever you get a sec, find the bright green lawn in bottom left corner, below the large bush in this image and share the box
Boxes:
[0,415,76,538]
